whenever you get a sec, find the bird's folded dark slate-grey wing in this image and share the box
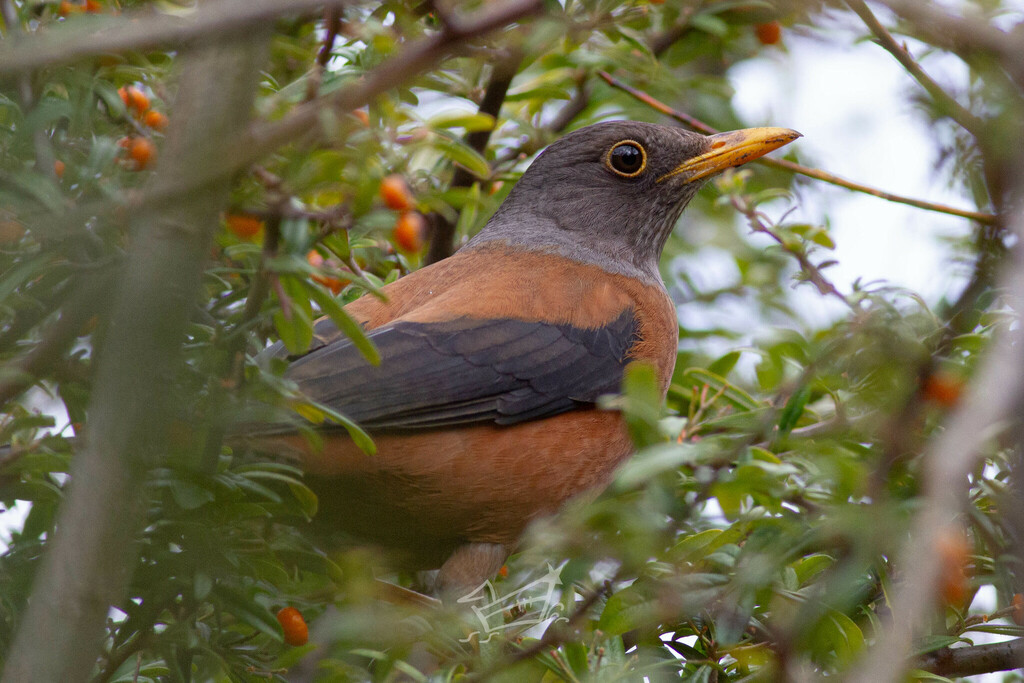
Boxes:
[286,309,637,429]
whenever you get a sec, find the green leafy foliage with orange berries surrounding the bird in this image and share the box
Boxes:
[0,0,1024,681]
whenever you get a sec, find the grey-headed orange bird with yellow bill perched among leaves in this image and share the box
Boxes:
[256,121,800,596]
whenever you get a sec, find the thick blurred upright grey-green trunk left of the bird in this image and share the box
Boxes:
[3,36,270,683]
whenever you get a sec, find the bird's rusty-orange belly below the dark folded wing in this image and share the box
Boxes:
[280,410,632,563]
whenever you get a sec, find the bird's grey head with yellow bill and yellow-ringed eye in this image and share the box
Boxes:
[470,121,800,282]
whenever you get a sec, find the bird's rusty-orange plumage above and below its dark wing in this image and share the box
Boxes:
[268,244,678,561]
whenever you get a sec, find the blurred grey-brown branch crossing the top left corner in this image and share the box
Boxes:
[0,0,342,76]
